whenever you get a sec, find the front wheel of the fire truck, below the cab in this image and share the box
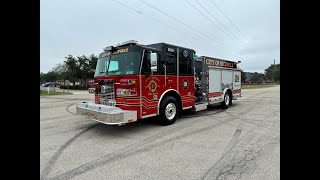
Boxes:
[159,96,179,126]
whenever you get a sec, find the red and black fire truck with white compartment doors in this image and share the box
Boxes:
[77,40,241,125]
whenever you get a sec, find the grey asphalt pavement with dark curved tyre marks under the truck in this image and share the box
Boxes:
[40,86,280,180]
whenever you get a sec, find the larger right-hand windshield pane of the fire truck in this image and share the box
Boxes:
[107,52,141,75]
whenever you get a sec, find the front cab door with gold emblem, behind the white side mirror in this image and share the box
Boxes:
[141,47,182,118]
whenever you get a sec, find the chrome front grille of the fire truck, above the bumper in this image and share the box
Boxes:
[96,79,116,106]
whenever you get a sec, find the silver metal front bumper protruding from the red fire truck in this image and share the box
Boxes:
[77,102,137,125]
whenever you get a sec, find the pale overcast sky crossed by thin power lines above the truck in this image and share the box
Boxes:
[40,0,280,73]
